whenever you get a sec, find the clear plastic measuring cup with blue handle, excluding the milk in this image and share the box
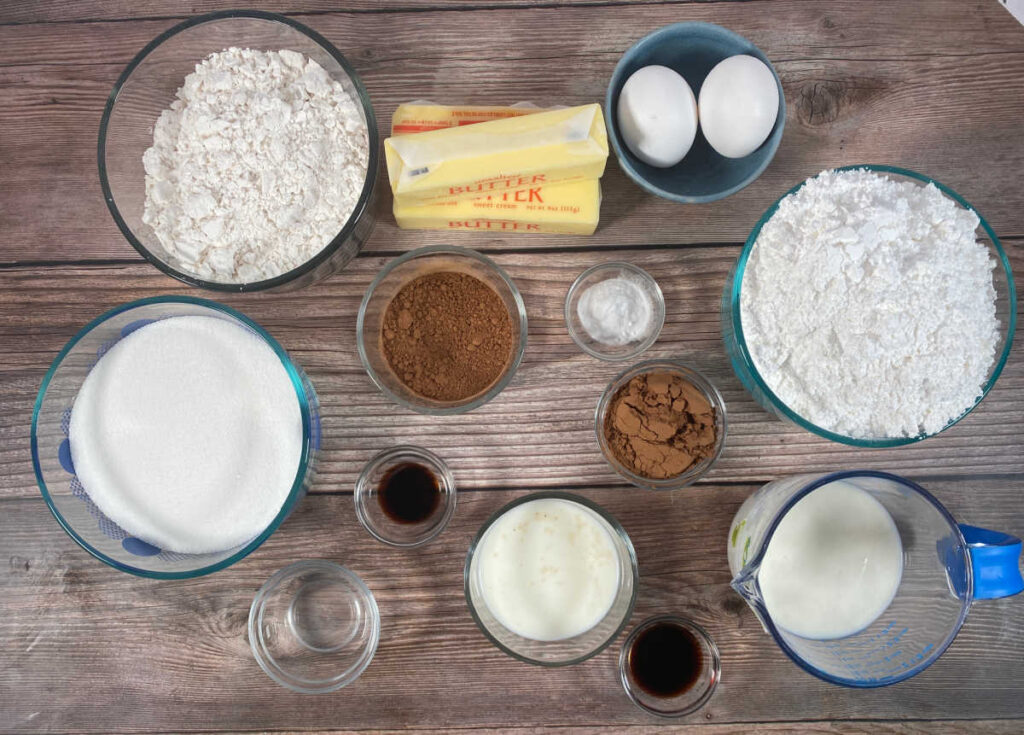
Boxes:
[728,470,1024,687]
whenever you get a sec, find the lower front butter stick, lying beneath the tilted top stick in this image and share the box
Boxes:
[394,179,601,234]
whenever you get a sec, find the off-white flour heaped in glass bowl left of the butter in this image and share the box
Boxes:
[142,48,369,284]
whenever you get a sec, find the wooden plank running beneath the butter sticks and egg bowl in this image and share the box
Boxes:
[0,0,1024,262]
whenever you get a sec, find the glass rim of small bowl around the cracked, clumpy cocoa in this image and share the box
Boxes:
[594,358,729,490]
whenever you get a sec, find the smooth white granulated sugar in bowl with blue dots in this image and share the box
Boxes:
[70,316,302,553]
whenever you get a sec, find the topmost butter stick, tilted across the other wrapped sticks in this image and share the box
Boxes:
[384,104,608,205]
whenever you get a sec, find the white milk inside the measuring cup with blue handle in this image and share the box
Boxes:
[758,480,903,640]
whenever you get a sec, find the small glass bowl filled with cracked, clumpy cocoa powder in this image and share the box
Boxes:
[595,359,727,490]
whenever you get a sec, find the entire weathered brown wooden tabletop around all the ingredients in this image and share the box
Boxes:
[0,0,1024,733]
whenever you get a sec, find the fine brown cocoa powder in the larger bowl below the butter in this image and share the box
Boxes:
[381,271,515,401]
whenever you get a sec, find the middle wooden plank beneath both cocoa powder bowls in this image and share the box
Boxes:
[0,247,1024,496]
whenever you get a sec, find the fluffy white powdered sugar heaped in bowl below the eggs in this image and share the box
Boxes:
[740,170,999,438]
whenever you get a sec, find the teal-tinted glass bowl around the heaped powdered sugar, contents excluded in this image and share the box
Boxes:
[725,164,1017,448]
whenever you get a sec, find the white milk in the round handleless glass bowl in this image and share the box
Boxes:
[476,498,620,641]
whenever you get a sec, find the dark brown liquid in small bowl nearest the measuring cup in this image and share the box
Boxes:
[628,622,703,698]
